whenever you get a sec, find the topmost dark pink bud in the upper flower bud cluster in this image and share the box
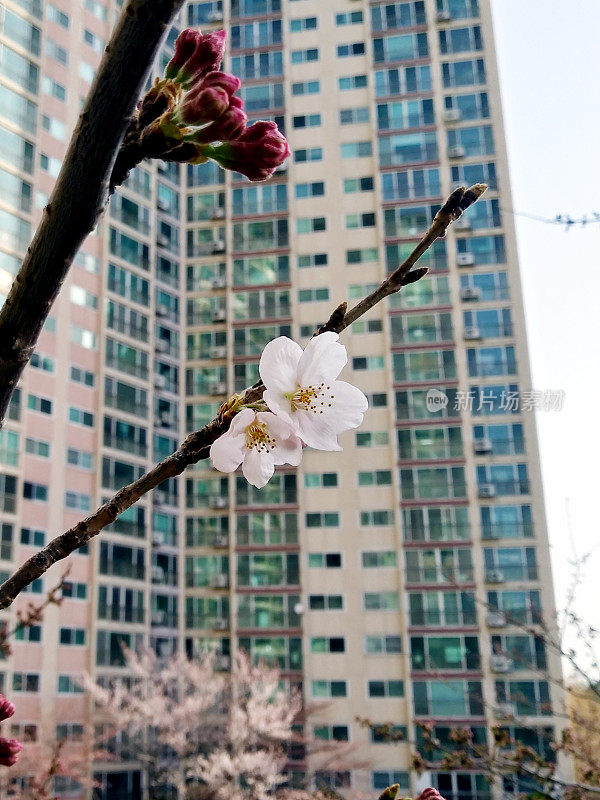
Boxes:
[165,28,227,88]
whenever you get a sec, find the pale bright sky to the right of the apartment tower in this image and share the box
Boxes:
[491,0,600,676]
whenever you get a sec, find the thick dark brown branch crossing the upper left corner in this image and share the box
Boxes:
[0,0,183,432]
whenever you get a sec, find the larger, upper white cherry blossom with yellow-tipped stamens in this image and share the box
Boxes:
[259,331,368,450]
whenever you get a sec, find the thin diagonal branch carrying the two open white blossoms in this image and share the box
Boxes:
[0,184,487,609]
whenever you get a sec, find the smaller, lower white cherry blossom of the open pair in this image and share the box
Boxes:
[210,408,302,489]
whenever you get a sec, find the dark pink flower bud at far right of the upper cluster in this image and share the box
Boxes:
[202,121,290,181]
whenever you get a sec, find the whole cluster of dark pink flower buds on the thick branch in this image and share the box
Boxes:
[138,29,290,181]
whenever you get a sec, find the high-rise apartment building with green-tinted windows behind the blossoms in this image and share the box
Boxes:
[0,0,560,800]
